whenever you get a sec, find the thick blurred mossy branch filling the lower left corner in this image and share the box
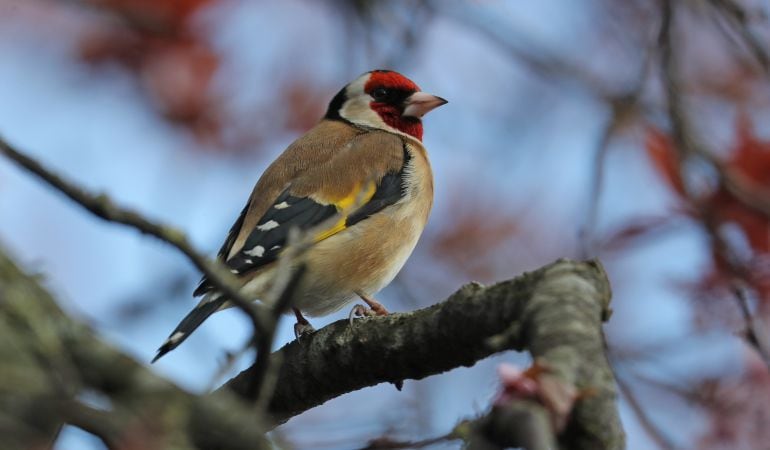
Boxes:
[0,251,268,449]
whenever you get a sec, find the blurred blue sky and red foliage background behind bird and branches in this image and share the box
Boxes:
[0,0,770,450]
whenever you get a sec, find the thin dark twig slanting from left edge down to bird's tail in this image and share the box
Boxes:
[0,138,268,333]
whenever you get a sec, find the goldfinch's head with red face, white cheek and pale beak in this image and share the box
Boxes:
[326,70,447,140]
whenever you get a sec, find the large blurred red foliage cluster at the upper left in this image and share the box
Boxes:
[80,0,221,141]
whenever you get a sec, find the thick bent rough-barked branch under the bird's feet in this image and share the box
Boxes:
[225,260,624,450]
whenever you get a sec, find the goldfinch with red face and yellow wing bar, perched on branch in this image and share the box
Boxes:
[152,70,447,363]
